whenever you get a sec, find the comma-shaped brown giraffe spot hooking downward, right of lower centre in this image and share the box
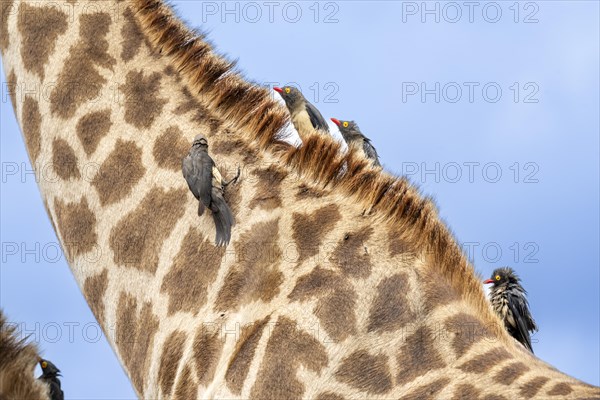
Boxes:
[288,267,357,341]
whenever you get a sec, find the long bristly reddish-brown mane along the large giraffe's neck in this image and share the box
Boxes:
[131,0,511,343]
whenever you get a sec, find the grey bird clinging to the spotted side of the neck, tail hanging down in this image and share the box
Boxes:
[181,135,240,246]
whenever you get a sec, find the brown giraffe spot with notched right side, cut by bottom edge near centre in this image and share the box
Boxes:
[250,317,328,400]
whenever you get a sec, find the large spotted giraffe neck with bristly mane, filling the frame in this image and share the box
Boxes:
[0,0,600,400]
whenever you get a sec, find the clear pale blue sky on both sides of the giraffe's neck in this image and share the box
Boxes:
[0,1,600,399]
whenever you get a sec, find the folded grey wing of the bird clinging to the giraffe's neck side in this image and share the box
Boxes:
[181,151,214,207]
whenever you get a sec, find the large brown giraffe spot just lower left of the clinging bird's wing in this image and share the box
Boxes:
[109,187,187,274]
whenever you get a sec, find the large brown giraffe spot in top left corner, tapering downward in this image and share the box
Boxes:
[17,3,68,80]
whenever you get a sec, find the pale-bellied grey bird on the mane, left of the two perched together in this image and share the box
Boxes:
[273,86,329,133]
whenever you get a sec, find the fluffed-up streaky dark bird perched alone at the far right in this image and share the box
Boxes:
[483,267,538,353]
